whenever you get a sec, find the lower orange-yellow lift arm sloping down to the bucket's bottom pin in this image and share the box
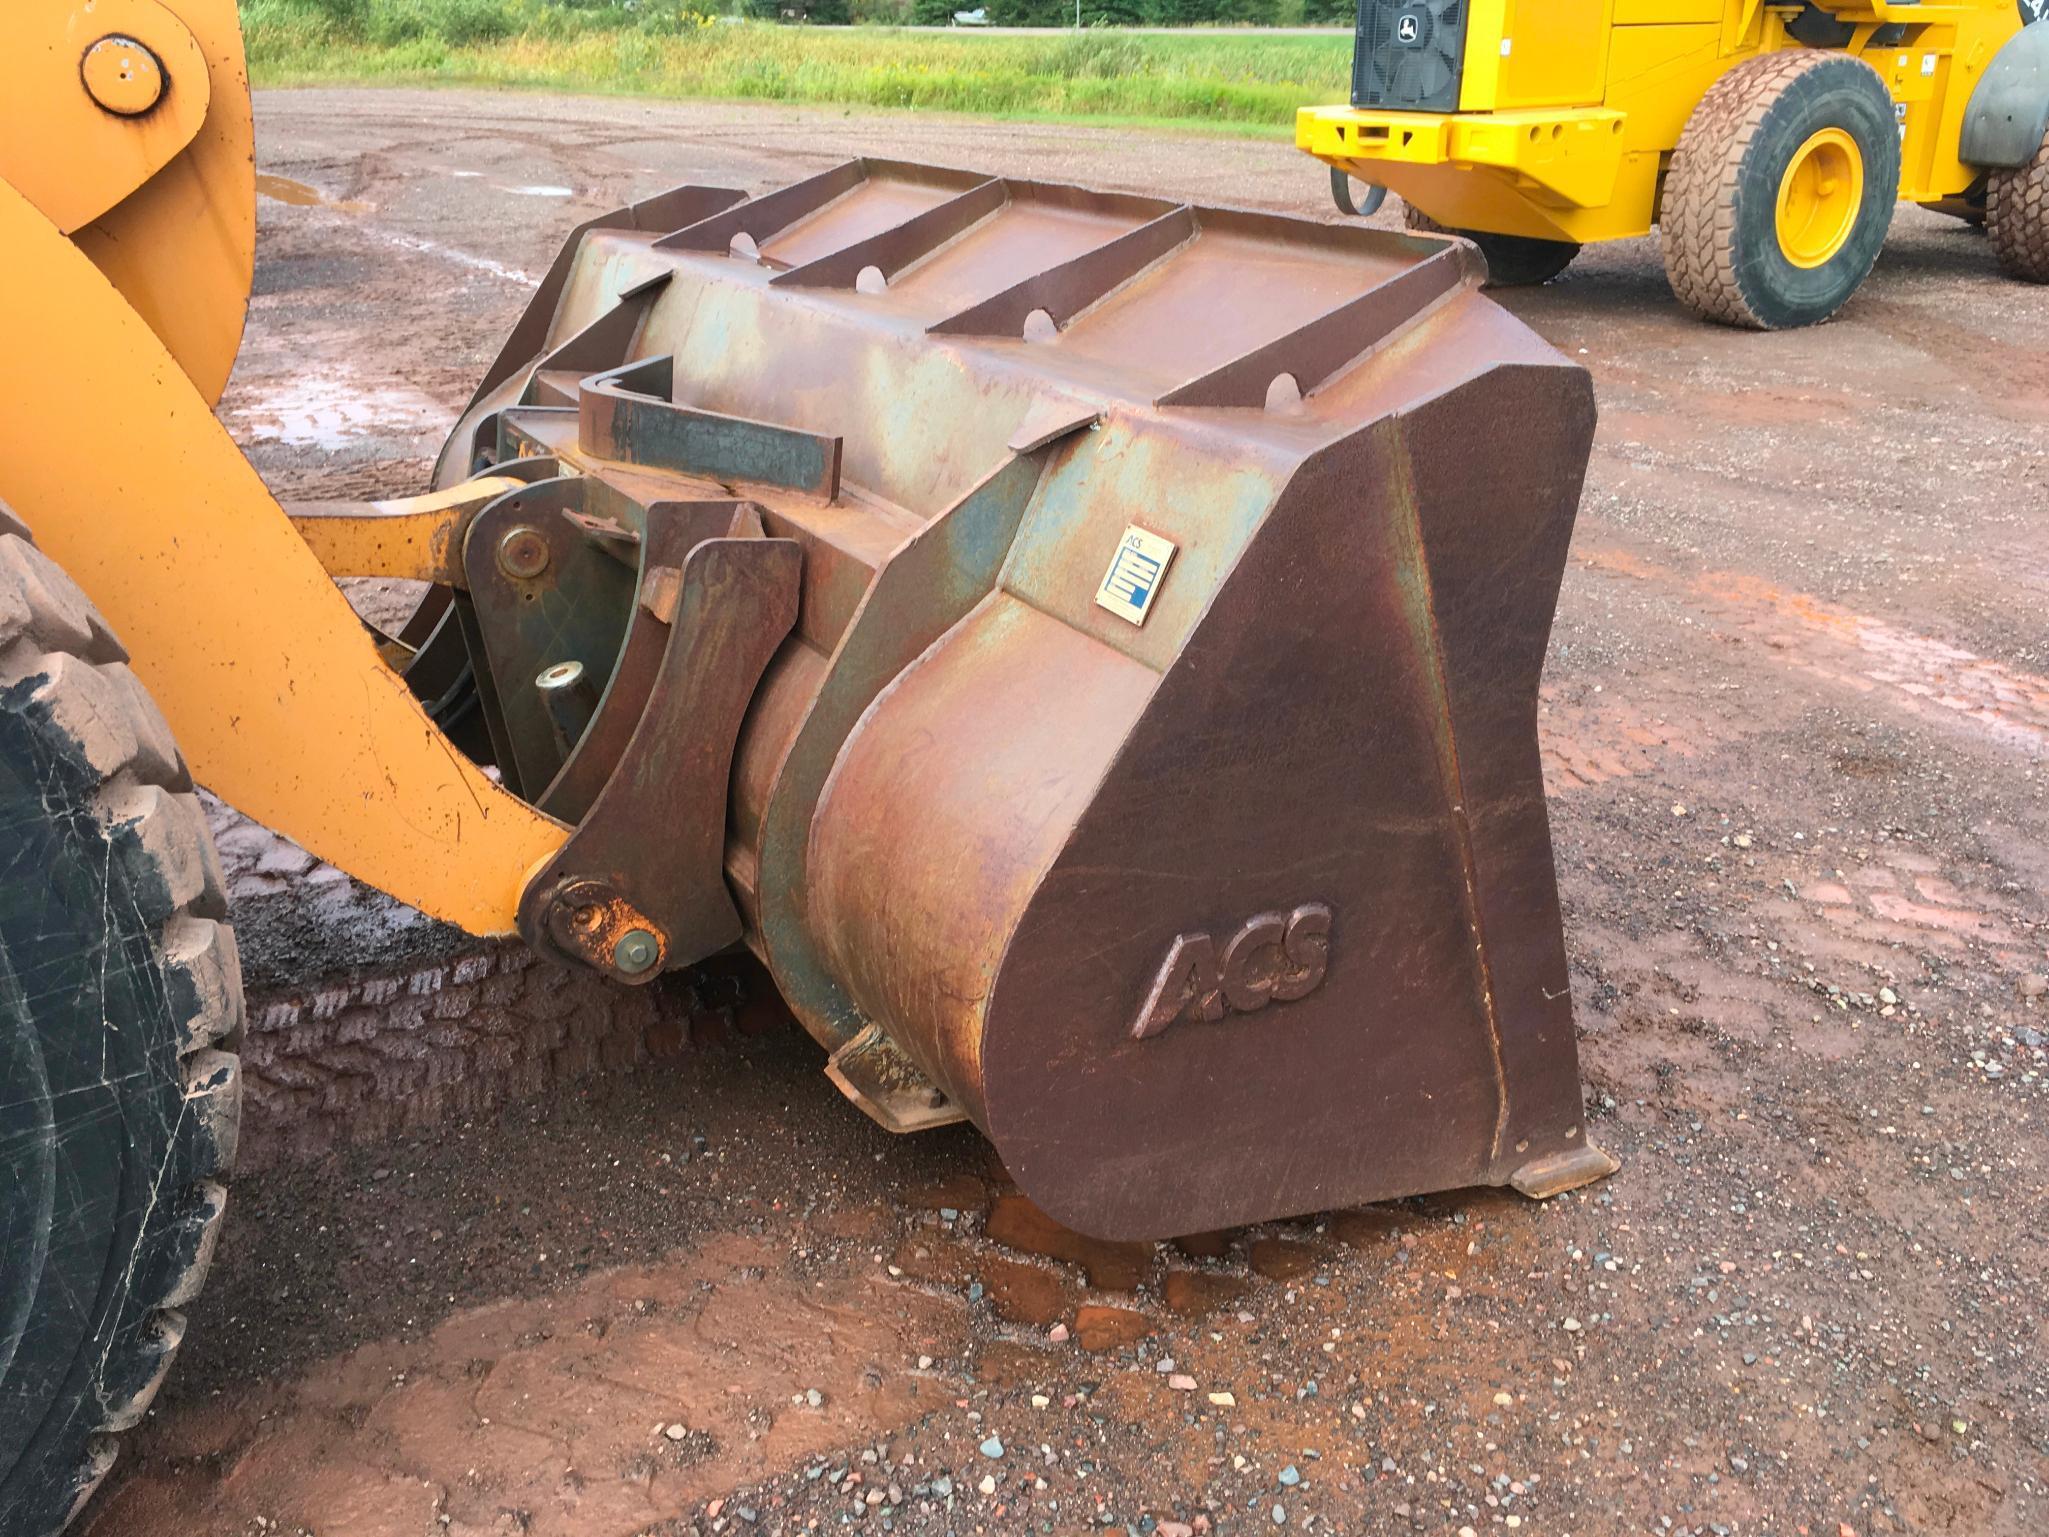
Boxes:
[0,184,568,934]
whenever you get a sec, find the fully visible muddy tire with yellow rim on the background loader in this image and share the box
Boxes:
[1660,49,1899,330]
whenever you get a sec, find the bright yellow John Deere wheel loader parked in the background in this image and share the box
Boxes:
[1295,0,2049,330]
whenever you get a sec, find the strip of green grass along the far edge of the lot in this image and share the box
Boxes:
[242,0,1350,133]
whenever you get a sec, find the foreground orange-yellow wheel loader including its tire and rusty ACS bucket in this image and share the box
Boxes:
[0,0,1615,1537]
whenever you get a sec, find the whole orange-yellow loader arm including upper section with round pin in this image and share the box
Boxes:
[0,0,568,934]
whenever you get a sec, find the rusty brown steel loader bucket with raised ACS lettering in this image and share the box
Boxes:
[422,160,1613,1236]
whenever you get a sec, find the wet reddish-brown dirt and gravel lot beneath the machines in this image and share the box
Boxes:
[72,90,2049,1537]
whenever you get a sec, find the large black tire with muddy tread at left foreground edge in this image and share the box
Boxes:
[0,506,242,1537]
